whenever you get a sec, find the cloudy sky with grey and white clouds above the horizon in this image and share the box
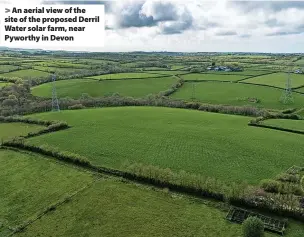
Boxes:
[2,0,304,53]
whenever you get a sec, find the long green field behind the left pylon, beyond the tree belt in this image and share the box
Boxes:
[32,77,177,98]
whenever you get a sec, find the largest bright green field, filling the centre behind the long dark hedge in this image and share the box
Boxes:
[28,107,304,183]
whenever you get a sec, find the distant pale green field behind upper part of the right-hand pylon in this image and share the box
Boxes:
[244,73,304,88]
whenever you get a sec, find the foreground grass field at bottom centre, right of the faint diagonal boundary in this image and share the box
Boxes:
[17,180,241,237]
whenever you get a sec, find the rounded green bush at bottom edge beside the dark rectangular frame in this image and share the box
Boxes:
[243,217,264,237]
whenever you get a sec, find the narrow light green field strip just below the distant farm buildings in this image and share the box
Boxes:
[181,73,246,81]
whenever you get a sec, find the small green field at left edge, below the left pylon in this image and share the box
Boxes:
[0,123,43,140]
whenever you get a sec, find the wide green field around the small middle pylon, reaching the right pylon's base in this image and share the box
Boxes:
[171,82,304,109]
